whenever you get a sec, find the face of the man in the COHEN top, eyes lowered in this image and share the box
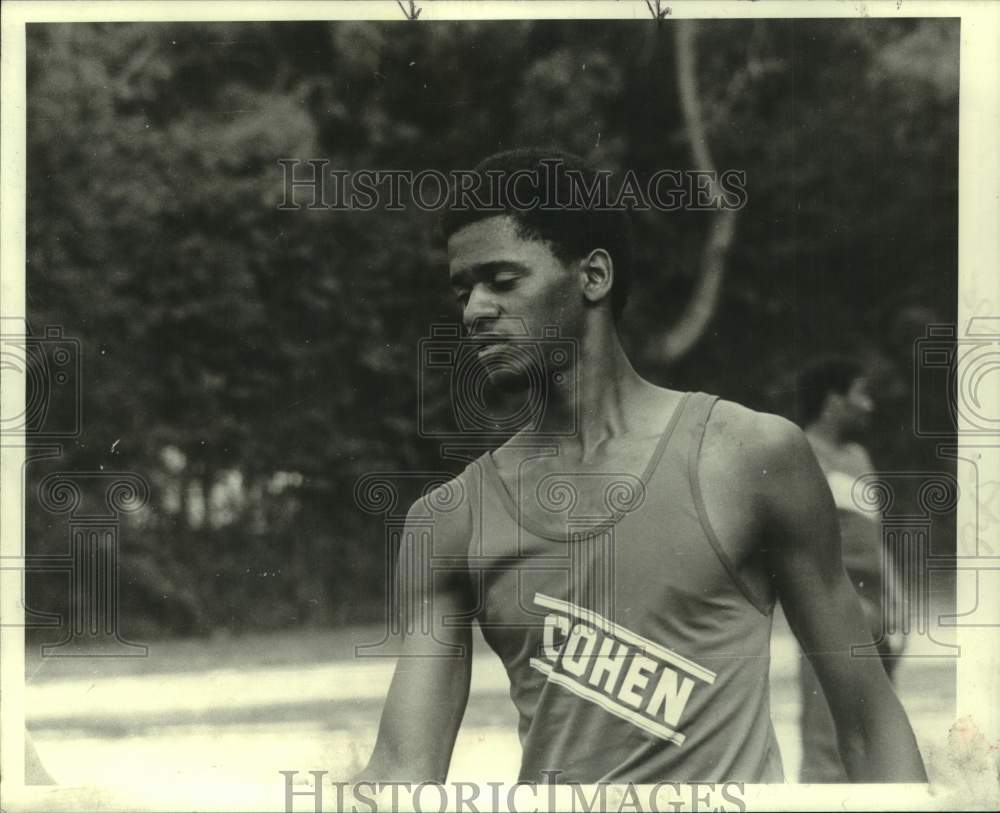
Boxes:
[448,215,584,386]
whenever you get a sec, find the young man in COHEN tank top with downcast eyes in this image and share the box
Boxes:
[359,151,925,783]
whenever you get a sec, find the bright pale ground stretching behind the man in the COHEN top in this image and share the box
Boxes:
[27,604,955,784]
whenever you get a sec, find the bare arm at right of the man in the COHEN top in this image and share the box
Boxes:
[753,416,927,782]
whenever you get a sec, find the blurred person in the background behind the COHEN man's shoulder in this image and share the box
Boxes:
[797,358,901,782]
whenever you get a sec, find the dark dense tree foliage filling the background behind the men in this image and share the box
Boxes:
[27,19,958,634]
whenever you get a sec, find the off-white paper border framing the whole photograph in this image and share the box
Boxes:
[0,0,1000,811]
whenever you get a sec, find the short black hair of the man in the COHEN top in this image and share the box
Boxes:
[441,147,632,320]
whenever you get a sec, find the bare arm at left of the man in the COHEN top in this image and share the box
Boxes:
[354,486,472,783]
